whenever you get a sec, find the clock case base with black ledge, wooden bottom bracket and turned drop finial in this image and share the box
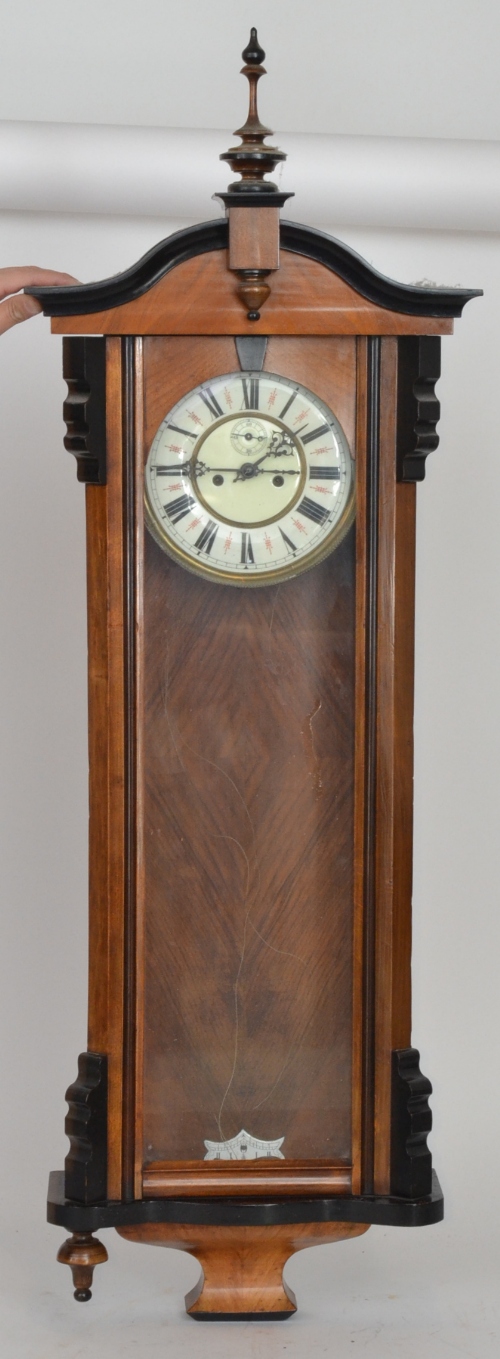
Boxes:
[48,1170,443,1321]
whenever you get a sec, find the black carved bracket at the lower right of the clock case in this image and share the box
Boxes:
[391,1048,432,1199]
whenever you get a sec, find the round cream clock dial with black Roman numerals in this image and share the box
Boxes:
[145,372,355,586]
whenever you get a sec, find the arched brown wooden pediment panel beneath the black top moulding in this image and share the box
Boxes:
[52,250,454,336]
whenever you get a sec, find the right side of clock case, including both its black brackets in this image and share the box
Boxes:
[372,337,440,1196]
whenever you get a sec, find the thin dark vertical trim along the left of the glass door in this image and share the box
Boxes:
[122,336,137,1201]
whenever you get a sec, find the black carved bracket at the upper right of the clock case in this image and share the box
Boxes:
[397,336,442,481]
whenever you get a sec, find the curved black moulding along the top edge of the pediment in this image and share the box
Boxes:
[26,220,482,317]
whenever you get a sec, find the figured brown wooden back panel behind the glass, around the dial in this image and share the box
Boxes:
[138,338,356,1162]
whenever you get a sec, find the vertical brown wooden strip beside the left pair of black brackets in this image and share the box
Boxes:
[86,340,125,1199]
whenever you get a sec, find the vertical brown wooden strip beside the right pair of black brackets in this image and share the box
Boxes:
[374,340,416,1193]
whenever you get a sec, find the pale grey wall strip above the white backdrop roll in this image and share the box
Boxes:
[0,0,500,139]
